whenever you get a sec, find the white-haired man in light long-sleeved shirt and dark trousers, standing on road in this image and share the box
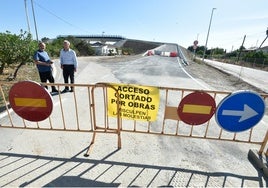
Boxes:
[60,40,78,93]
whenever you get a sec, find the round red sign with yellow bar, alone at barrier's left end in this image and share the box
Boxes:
[9,81,53,122]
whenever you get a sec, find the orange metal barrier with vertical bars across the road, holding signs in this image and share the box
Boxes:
[0,82,268,156]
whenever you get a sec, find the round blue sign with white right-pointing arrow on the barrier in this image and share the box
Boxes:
[215,91,265,132]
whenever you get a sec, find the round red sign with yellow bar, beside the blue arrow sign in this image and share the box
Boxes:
[177,92,216,125]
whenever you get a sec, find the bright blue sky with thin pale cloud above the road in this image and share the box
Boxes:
[0,0,268,52]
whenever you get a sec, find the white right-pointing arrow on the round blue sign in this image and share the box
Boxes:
[222,104,258,122]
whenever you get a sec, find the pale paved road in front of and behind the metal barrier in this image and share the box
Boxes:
[0,45,267,187]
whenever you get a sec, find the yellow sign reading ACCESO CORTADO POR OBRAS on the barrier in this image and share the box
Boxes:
[108,84,159,121]
